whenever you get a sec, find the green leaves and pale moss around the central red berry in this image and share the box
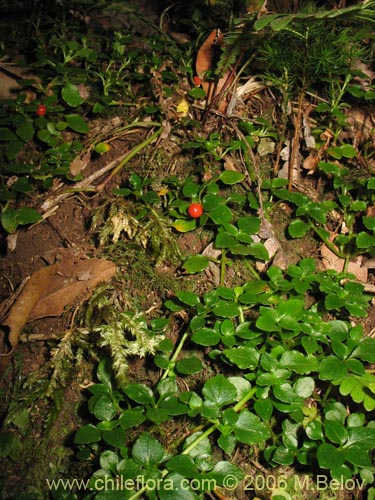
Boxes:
[113,171,269,283]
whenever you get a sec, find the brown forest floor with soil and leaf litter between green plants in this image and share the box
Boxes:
[0,2,375,500]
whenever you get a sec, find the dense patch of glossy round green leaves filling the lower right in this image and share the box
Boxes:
[75,259,375,500]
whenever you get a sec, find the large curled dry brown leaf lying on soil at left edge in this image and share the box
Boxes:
[2,257,116,355]
